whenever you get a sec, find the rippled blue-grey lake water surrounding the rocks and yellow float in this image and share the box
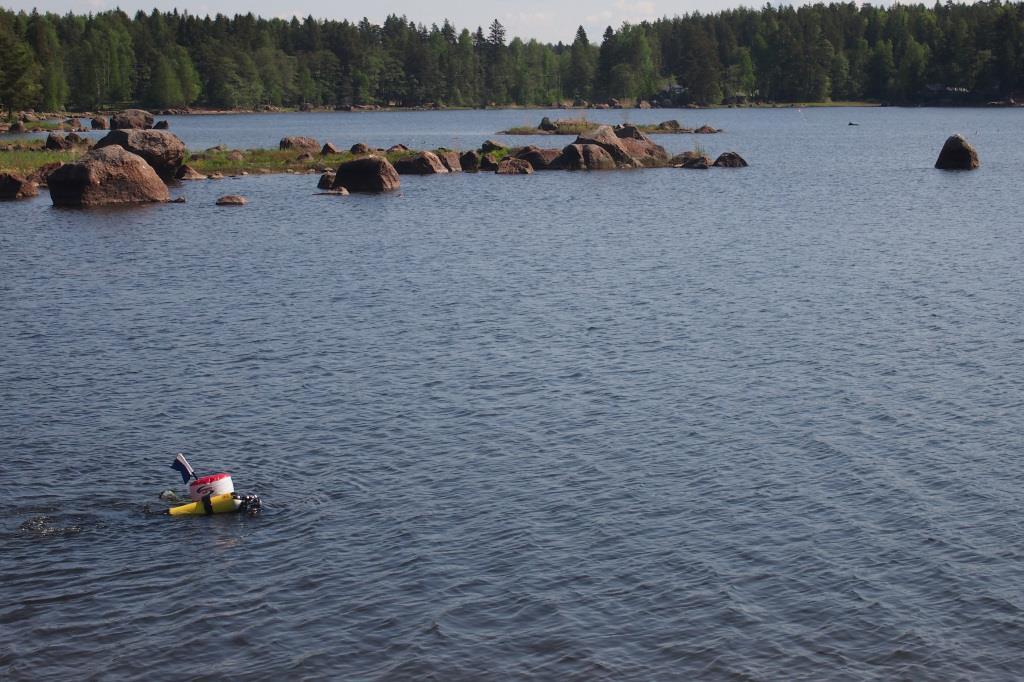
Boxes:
[0,109,1024,680]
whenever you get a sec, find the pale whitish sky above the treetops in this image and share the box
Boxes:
[0,0,823,43]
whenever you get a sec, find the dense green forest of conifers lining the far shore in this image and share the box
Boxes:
[0,1,1024,111]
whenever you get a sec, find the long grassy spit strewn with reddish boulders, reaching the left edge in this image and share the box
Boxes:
[0,110,746,207]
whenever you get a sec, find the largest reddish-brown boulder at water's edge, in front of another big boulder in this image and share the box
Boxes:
[47,145,171,207]
